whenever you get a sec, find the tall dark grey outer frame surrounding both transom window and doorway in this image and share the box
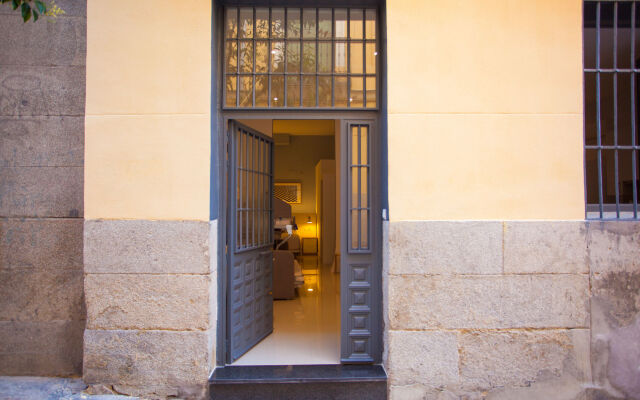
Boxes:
[211,0,389,366]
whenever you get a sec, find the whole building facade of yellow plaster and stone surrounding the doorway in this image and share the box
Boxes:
[0,0,640,399]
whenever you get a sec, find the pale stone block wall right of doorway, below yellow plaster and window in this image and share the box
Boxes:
[384,221,640,400]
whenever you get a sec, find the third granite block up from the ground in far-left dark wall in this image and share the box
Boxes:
[0,218,83,270]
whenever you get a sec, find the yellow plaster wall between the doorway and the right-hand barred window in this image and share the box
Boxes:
[387,0,584,220]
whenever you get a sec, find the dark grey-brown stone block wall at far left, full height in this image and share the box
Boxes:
[0,0,86,376]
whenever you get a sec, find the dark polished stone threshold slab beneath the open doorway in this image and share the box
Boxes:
[209,364,387,385]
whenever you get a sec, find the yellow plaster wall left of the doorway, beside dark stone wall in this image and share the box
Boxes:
[85,0,211,220]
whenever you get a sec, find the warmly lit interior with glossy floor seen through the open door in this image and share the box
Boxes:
[231,119,340,365]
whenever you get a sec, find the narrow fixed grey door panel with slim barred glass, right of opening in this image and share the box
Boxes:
[340,120,382,363]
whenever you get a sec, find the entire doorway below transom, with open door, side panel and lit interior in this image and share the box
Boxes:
[224,113,381,365]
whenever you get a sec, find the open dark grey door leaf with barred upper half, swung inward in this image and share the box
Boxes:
[227,121,273,363]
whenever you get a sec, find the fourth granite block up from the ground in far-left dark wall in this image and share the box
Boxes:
[0,167,84,218]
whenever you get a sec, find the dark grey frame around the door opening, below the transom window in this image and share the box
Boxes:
[216,110,385,366]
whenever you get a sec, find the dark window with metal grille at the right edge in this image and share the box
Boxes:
[583,0,640,219]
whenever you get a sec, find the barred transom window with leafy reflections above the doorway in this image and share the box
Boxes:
[224,7,379,109]
